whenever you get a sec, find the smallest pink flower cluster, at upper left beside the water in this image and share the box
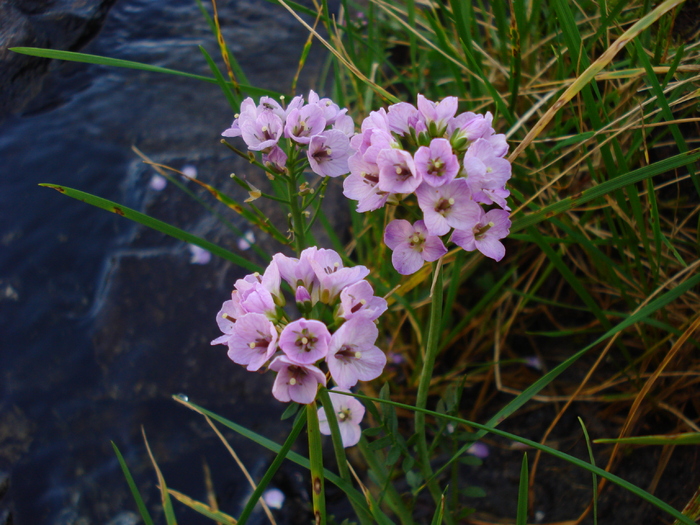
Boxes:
[222,91,355,177]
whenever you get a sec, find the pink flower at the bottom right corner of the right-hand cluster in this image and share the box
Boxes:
[451,206,511,261]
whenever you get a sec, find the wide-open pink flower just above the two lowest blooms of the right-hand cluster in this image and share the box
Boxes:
[416,179,481,235]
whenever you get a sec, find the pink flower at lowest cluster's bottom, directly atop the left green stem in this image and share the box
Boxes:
[270,355,326,405]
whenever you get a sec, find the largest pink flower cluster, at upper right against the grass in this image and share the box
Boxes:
[343,95,511,275]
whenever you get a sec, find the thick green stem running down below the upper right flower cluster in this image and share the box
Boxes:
[414,261,452,523]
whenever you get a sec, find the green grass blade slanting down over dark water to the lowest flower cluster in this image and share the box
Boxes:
[39,184,262,272]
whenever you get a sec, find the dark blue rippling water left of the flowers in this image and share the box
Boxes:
[0,0,328,525]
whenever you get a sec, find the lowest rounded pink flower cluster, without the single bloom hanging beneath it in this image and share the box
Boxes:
[211,247,387,410]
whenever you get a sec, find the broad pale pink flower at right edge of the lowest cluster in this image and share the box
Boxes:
[326,317,386,388]
